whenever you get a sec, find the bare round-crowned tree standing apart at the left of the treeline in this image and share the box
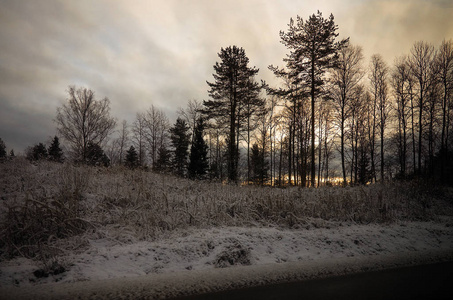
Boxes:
[55,86,116,161]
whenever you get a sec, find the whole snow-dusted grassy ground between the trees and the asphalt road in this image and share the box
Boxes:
[0,163,453,300]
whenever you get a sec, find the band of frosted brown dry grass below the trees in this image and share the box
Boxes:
[0,158,453,261]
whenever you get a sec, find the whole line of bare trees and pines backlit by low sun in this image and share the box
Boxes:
[0,12,453,186]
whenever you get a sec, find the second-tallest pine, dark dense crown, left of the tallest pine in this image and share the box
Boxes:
[203,46,261,182]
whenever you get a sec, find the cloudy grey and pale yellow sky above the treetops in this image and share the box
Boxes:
[0,0,453,153]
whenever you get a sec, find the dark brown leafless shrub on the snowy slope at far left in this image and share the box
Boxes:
[0,164,92,258]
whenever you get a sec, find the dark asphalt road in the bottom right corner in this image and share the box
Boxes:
[178,262,453,300]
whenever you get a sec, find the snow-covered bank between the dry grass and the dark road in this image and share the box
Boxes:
[0,217,453,299]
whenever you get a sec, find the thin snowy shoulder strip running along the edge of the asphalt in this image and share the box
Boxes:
[0,249,453,300]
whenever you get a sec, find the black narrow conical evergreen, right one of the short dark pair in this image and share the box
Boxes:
[188,118,208,179]
